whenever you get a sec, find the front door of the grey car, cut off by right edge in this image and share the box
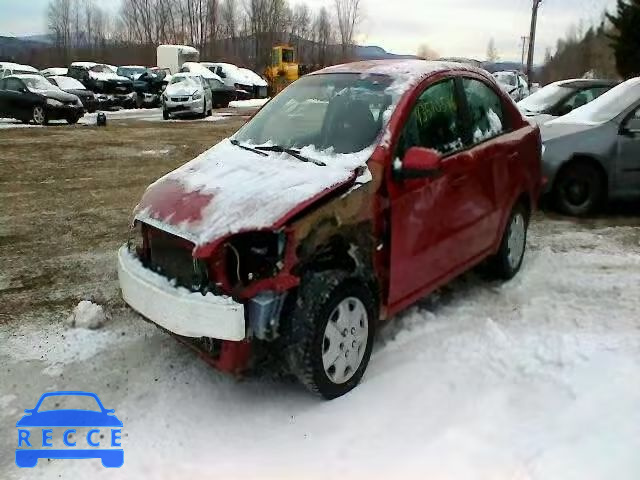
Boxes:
[615,107,640,195]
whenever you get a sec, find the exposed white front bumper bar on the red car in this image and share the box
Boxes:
[118,245,246,341]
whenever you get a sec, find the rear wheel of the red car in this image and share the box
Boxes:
[489,203,529,280]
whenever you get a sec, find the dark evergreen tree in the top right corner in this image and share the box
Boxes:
[607,0,640,79]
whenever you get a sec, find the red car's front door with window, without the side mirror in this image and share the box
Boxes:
[389,78,472,308]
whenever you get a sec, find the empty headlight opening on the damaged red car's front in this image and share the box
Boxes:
[224,232,286,289]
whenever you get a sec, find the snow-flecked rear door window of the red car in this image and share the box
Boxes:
[462,78,506,144]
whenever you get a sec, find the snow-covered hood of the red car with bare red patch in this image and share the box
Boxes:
[135,139,374,247]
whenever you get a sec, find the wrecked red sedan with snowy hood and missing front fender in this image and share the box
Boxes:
[118,60,541,398]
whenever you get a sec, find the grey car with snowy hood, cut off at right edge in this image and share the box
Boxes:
[542,78,640,215]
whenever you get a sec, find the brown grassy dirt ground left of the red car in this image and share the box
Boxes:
[0,117,245,323]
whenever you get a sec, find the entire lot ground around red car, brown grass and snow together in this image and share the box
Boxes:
[0,114,640,480]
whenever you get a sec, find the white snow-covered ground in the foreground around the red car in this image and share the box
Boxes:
[0,217,640,480]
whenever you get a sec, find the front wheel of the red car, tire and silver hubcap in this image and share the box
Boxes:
[285,270,378,400]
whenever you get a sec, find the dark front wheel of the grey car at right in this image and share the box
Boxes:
[553,162,605,217]
